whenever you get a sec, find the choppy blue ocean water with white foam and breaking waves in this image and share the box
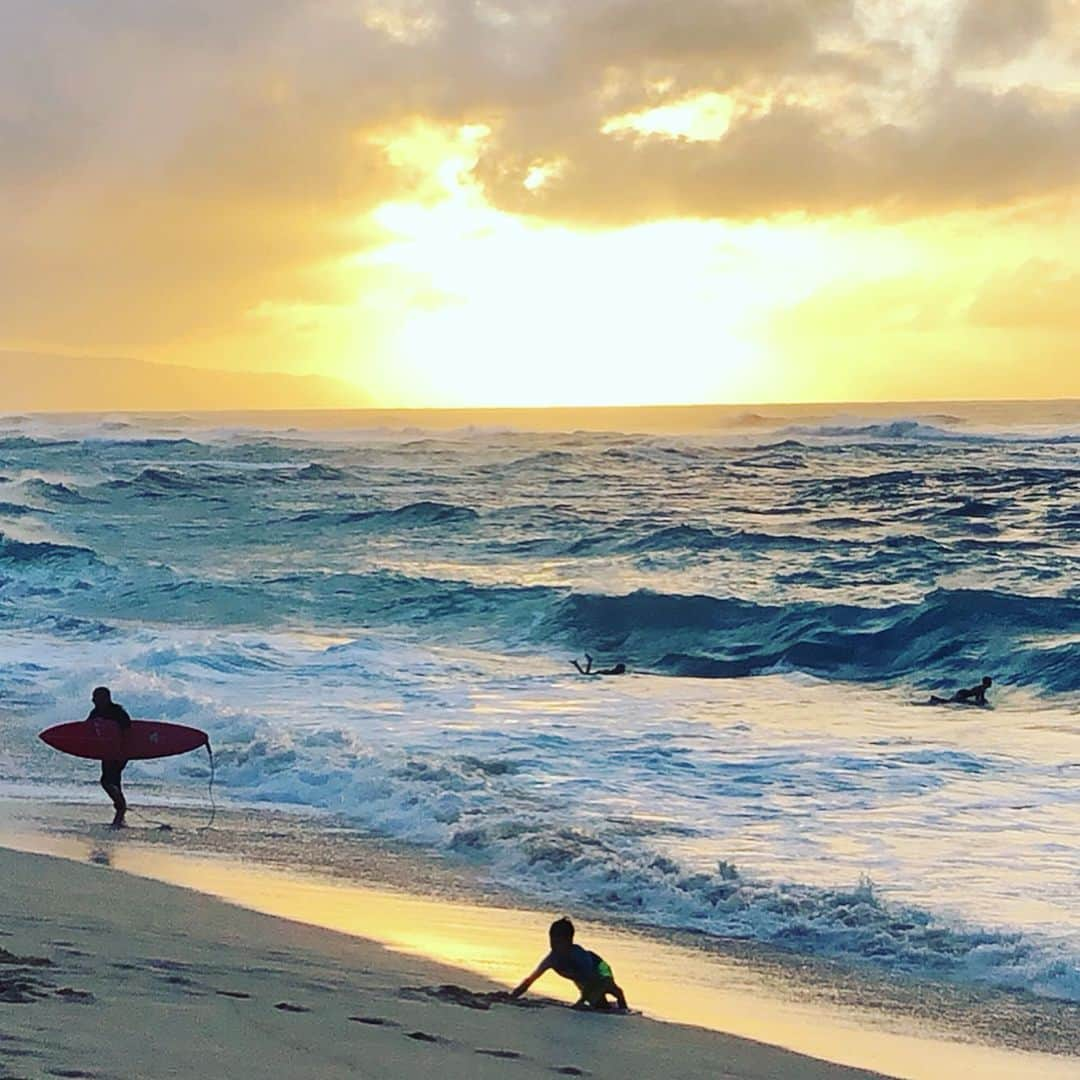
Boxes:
[0,403,1080,1000]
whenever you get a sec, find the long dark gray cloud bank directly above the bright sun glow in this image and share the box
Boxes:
[481,83,1080,225]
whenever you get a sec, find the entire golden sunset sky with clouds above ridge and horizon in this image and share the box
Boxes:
[0,0,1080,406]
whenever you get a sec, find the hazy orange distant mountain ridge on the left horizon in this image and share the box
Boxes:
[0,350,372,413]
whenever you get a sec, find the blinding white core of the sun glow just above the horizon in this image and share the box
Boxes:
[358,191,756,405]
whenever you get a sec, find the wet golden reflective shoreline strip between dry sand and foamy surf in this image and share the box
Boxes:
[0,804,1077,1078]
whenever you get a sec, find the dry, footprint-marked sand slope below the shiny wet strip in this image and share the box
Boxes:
[0,850,898,1080]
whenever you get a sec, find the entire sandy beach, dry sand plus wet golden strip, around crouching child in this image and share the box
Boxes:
[0,800,1076,1080]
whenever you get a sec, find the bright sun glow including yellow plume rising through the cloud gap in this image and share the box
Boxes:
[354,126,924,406]
